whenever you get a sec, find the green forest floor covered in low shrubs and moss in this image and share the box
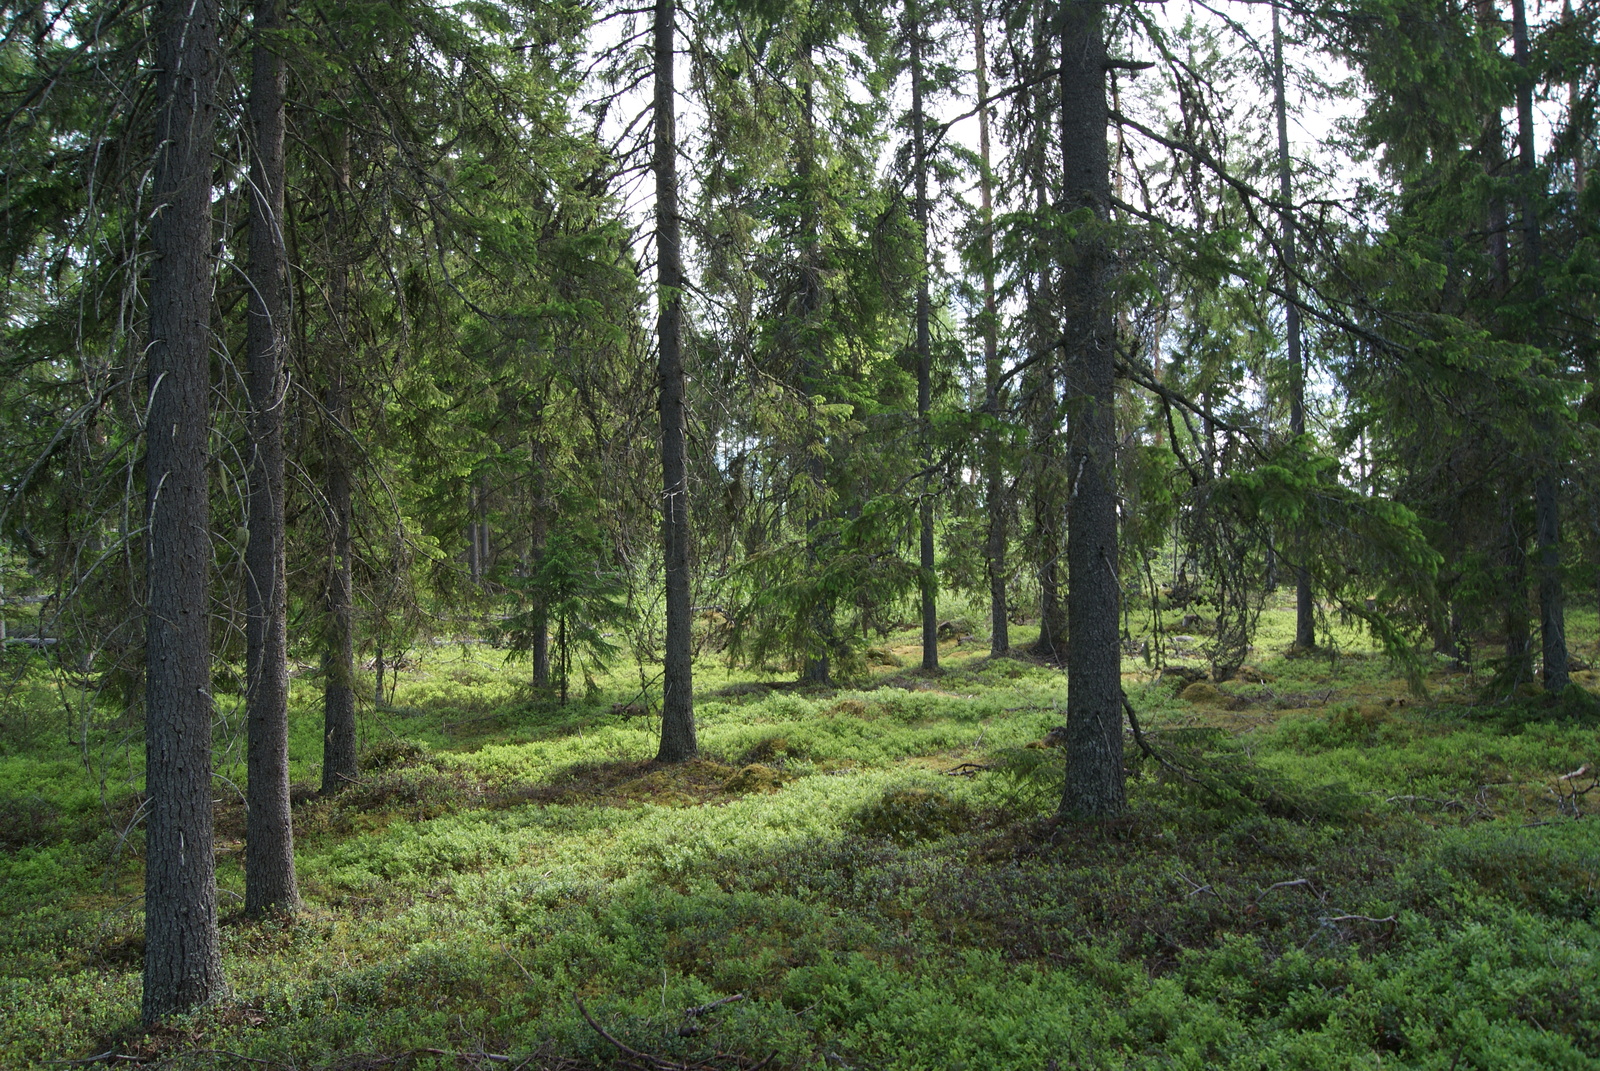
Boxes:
[0,607,1600,1071]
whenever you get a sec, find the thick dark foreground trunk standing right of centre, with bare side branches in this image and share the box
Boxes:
[1059,0,1126,818]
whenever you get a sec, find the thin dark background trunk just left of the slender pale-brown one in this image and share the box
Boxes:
[906,0,939,672]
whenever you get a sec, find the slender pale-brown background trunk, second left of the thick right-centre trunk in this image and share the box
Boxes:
[973,0,1011,658]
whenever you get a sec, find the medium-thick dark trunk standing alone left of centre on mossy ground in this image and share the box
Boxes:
[654,0,699,762]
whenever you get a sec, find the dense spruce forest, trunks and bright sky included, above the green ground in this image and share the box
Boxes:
[0,0,1600,1066]
